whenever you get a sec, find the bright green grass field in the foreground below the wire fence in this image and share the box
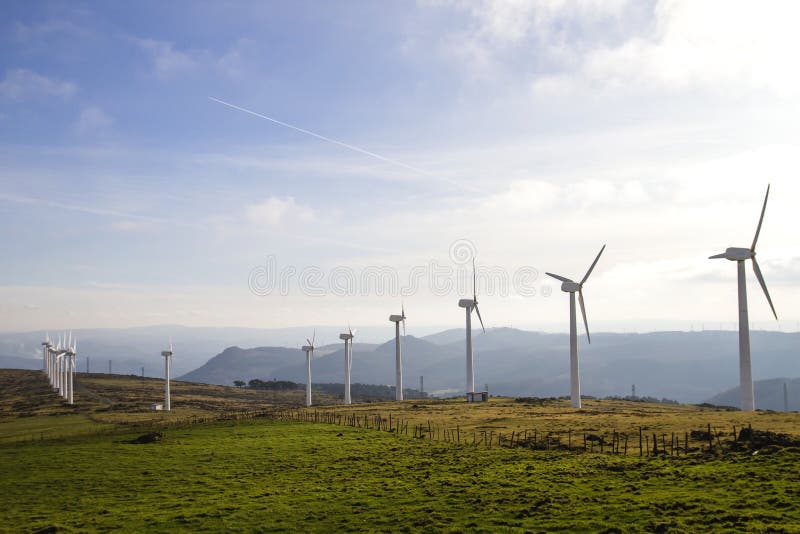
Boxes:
[0,374,800,532]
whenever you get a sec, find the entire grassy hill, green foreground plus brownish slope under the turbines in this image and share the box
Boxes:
[0,371,800,532]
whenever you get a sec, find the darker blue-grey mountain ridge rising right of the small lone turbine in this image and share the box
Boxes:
[177,328,800,405]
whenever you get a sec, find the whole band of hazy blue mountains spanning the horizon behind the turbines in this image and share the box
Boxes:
[0,326,800,409]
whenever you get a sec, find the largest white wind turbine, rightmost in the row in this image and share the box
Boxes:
[709,185,778,412]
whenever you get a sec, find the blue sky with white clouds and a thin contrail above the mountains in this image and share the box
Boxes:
[0,0,800,333]
